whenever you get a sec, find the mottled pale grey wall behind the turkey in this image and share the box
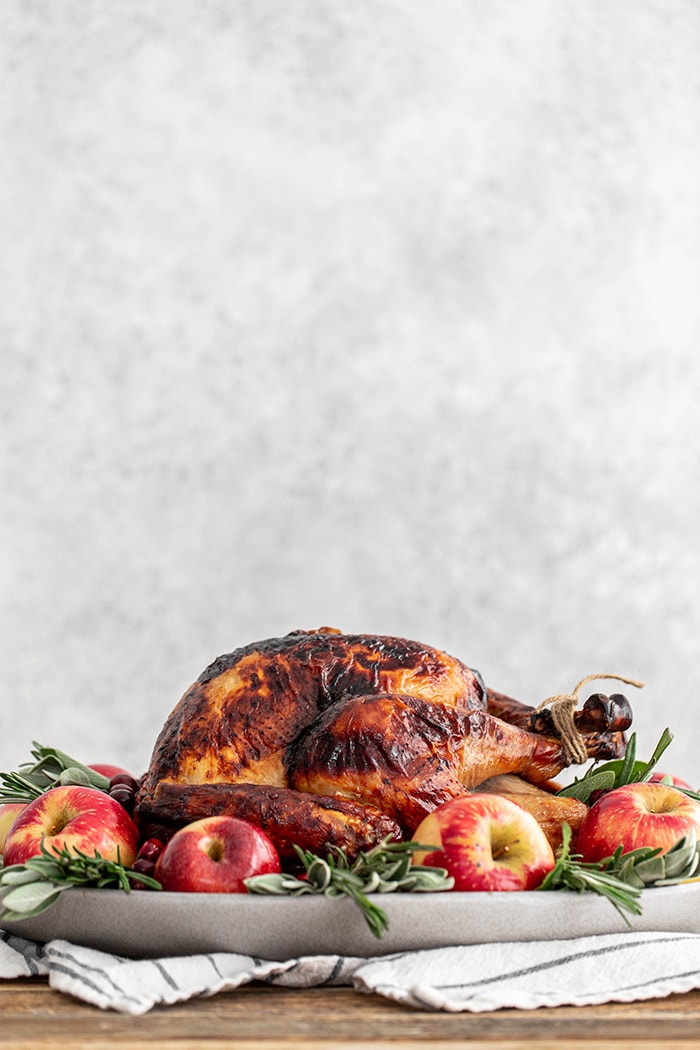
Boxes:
[0,0,700,783]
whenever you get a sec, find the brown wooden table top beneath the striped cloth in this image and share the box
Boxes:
[0,978,700,1050]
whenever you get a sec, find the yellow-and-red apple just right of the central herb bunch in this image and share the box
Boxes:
[413,794,554,890]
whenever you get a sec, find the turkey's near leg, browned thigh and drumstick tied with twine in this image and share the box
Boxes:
[289,694,625,834]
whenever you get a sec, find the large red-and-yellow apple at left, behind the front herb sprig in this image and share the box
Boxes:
[4,784,139,867]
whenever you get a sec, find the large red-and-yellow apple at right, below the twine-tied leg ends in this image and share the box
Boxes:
[576,782,700,861]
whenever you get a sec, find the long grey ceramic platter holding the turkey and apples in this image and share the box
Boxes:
[0,883,700,960]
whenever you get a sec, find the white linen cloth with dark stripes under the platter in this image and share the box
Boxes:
[0,931,700,1014]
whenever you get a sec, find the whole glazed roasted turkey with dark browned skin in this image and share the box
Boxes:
[136,628,631,857]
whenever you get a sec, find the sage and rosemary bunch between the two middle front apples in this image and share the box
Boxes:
[245,838,454,939]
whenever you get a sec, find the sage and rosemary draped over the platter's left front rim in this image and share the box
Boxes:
[0,841,161,921]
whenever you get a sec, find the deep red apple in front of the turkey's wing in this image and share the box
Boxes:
[154,817,281,894]
